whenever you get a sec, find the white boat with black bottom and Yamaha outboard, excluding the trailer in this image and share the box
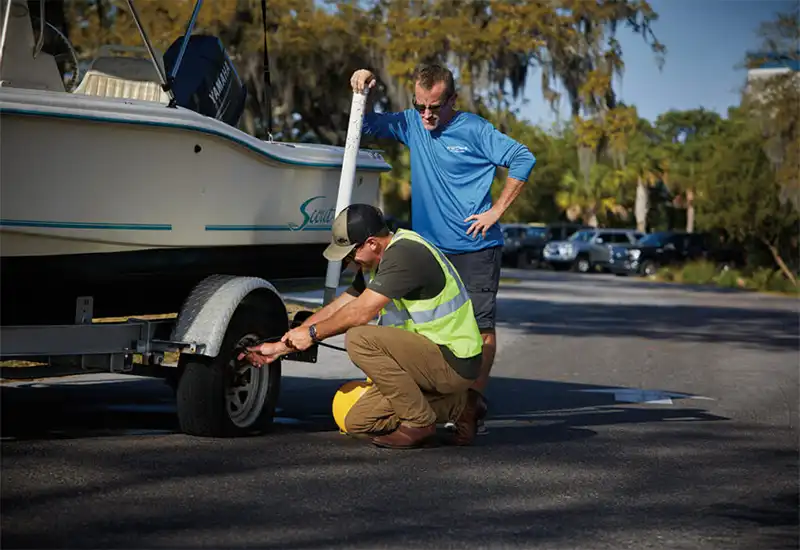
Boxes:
[0,0,390,324]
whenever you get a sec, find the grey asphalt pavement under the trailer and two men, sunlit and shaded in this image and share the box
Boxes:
[0,270,800,550]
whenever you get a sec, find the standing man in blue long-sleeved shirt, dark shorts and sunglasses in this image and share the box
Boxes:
[350,64,536,426]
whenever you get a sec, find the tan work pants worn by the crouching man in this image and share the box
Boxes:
[345,325,474,434]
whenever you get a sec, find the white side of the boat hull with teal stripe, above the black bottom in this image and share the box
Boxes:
[0,90,388,256]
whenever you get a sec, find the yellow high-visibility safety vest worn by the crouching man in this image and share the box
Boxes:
[369,229,483,359]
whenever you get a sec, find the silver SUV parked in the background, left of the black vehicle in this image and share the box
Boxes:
[542,229,644,273]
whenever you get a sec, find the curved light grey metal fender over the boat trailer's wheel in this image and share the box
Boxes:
[171,275,289,357]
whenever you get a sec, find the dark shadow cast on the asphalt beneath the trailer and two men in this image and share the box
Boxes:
[0,375,727,442]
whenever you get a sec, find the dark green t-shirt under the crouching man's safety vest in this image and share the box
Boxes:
[347,239,481,380]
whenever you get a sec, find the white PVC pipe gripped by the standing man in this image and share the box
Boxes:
[322,90,369,305]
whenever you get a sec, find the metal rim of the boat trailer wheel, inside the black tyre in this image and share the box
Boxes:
[225,335,269,428]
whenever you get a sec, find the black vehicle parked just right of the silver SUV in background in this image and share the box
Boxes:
[609,231,744,275]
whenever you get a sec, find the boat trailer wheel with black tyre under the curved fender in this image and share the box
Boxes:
[177,293,288,437]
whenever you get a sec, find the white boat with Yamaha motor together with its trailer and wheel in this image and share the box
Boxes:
[0,0,391,437]
